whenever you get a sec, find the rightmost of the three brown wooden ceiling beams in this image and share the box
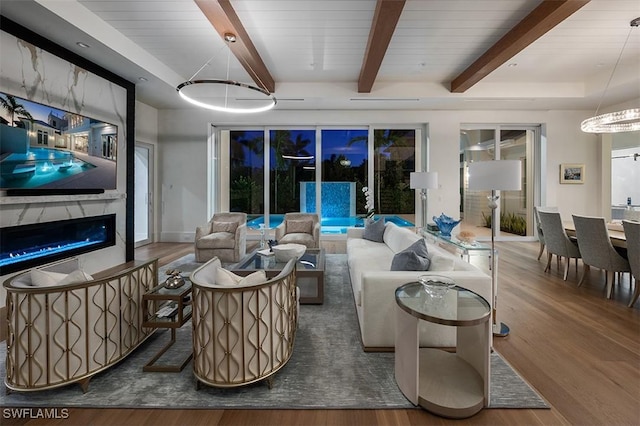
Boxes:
[451,0,590,93]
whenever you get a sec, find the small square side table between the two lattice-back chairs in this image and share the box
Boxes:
[142,278,193,373]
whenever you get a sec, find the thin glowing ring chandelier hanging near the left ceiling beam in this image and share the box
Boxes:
[176,33,277,114]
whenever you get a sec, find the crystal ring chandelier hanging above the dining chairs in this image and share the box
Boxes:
[580,18,640,133]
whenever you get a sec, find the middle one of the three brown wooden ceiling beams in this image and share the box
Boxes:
[358,0,405,93]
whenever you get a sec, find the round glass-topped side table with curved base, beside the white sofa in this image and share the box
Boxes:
[395,282,491,418]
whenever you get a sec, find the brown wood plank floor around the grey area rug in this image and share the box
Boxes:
[0,242,640,426]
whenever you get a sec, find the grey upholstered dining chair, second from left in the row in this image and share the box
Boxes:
[538,209,582,281]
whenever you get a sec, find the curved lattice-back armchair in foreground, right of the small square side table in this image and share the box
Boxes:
[191,257,298,388]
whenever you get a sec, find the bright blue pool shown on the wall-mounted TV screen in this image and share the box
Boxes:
[0,148,95,188]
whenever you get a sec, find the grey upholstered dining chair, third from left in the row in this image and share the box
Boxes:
[573,214,631,299]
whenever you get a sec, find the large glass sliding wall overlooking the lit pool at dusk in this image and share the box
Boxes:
[224,127,418,233]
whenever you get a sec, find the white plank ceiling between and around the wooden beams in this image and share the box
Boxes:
[0,0,640,110]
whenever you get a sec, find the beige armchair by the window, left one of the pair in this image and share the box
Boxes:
[195,213,247,262]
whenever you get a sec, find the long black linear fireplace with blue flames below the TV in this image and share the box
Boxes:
[0,214,116,275]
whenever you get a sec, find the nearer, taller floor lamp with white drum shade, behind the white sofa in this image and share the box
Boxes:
[467,160,522,337]
